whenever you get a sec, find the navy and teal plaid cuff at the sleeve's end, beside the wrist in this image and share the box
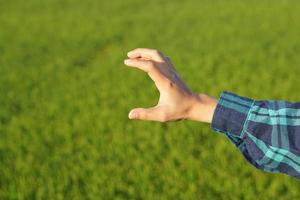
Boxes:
[211,92,254,139]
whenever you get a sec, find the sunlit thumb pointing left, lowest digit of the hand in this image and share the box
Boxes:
[128,106,166,122]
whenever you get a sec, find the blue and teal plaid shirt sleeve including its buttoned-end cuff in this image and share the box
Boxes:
[211,92,300,178]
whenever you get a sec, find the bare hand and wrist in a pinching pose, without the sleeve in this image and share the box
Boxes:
[124,48,217,123]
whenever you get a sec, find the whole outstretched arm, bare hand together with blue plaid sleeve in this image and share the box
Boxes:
[125,48,300,178]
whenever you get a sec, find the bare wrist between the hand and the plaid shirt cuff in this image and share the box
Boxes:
[187,94,218,123]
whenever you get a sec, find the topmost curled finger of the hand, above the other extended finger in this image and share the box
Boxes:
[127,48,164,62]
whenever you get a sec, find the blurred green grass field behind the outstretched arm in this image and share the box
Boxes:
[0,0,300,200]
